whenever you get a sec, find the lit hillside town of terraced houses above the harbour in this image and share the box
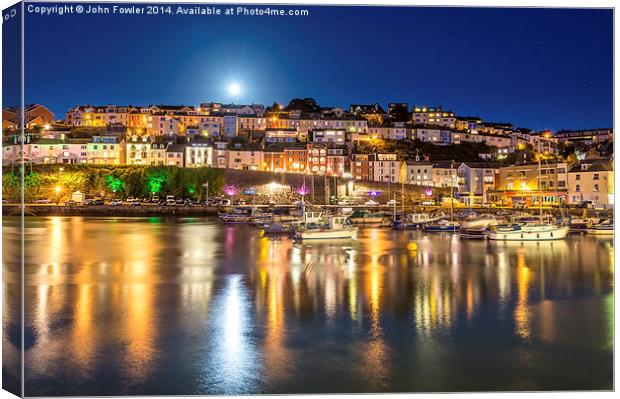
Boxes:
[2,98,614,209]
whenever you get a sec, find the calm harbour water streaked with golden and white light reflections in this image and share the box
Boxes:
[3,217,614,396]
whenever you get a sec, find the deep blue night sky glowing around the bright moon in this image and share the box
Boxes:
[12,4,613,130]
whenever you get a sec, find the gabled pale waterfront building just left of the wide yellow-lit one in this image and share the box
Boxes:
[457,162,499,206]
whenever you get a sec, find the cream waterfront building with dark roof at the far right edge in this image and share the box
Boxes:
[567,159,614,208]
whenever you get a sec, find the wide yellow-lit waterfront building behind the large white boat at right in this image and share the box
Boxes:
[490,162,568,207]
